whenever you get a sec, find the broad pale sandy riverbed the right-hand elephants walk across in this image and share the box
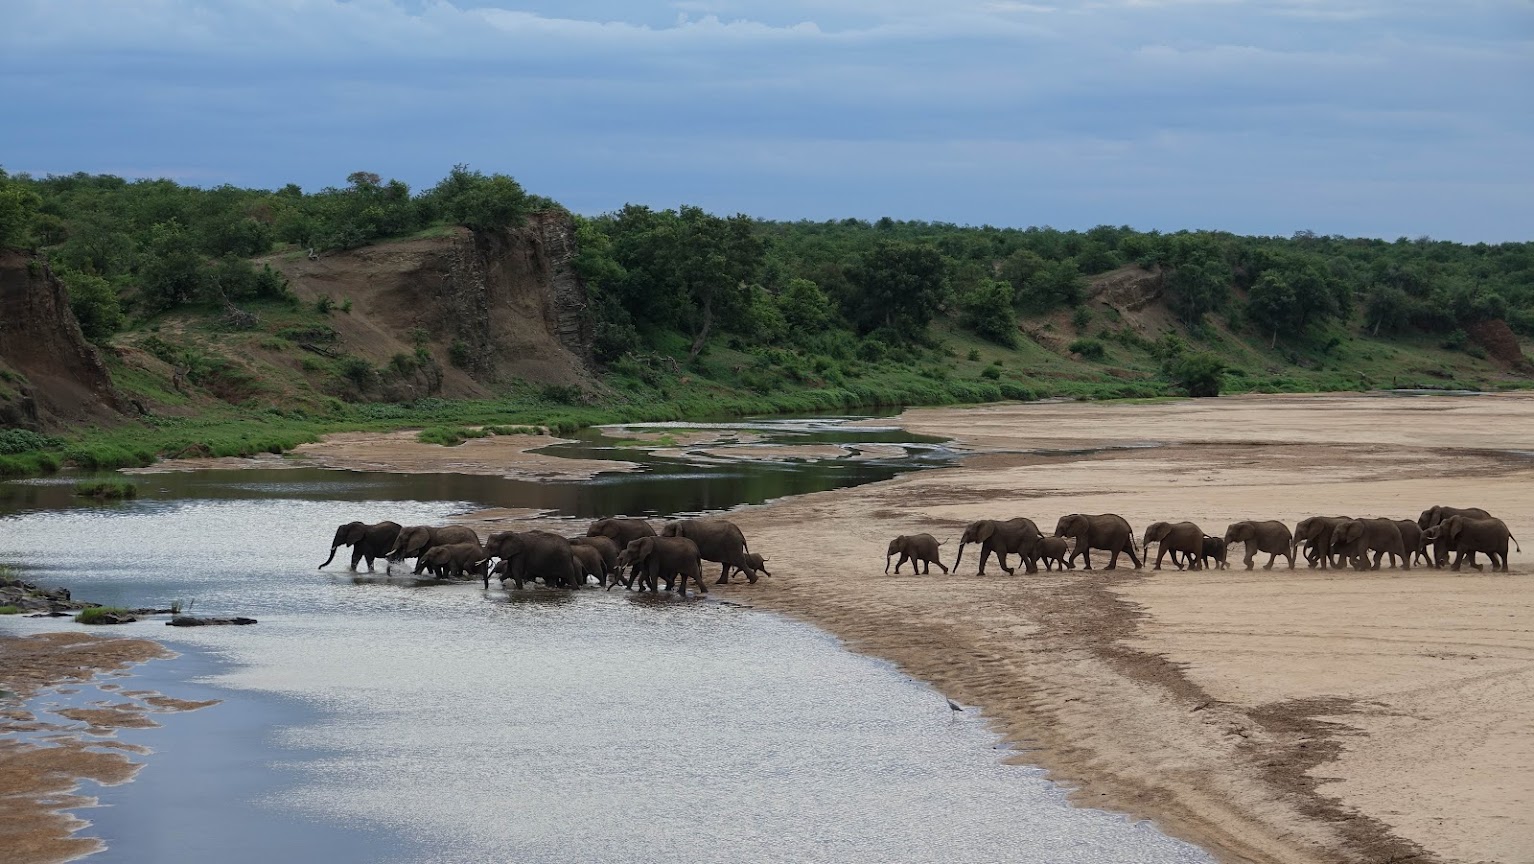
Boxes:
[715,396,1534,864]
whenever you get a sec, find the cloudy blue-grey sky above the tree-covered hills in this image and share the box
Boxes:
[0,0,1534,242]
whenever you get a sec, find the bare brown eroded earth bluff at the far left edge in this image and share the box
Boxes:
[0,252,123,430]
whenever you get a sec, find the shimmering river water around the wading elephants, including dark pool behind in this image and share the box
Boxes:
[0,419,1209,864]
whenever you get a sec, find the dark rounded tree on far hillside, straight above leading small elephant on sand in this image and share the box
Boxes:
[847,241,948,341]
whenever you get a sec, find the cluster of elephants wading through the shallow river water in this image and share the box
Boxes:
[319,519,772,597]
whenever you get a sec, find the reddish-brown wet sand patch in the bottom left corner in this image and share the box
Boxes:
[0,632,213,864]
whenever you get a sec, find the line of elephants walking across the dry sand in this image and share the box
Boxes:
[884,505,1523,575]
